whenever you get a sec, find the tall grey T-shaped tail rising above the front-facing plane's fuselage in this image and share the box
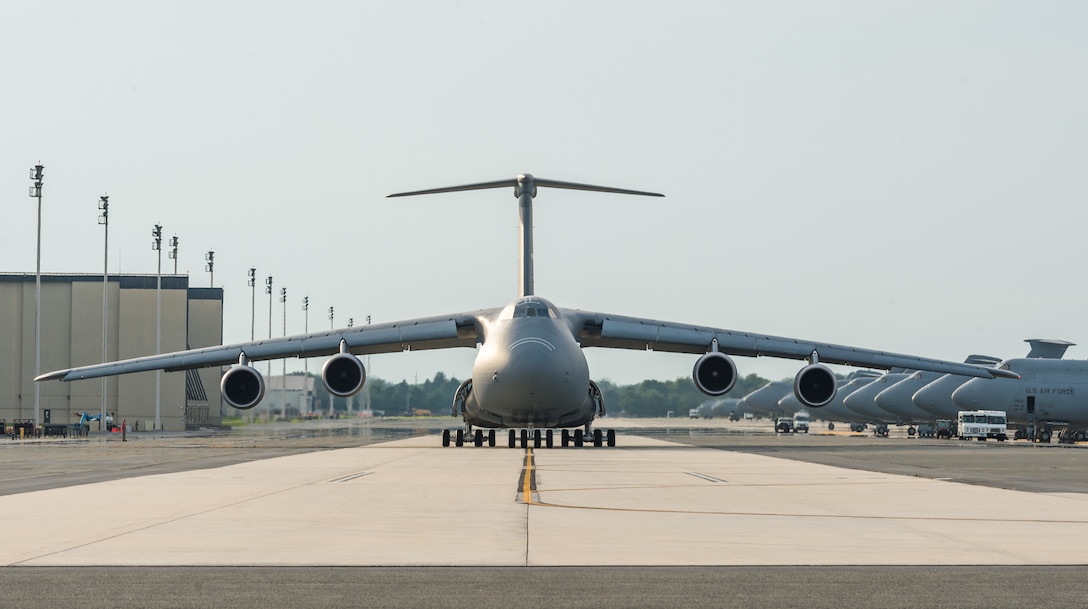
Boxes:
[390,173,665,298]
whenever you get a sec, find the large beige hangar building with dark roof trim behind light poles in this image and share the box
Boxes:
[0,273,223,431]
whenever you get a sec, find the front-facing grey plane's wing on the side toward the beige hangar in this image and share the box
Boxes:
[35,309,499,381]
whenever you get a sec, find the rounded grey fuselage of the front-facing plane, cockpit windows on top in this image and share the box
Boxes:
[463,297,595,427]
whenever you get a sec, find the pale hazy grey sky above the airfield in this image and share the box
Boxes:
[0,0,1088,383]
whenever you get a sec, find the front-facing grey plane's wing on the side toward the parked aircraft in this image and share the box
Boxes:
[562,309,1018,378]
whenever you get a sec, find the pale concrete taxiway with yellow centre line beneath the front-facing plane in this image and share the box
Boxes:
[0,435,1088,567]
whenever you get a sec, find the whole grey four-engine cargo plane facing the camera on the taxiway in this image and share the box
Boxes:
[37,174,1014,448]
